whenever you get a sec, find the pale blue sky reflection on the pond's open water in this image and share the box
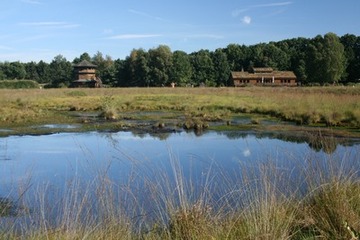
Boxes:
[0,132,359,201]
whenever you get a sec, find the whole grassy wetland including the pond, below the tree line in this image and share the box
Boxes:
[0,87,360,239]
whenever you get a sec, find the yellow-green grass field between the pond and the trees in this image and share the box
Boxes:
[0,87,360,137]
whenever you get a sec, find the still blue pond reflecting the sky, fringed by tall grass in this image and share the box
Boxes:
[0,131,360,227]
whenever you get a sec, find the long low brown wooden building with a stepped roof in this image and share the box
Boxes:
[231,68,297,87]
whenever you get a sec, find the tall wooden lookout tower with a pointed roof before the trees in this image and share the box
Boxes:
[70,60,102,88]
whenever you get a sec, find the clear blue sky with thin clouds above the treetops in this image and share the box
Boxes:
[0,0,360,62]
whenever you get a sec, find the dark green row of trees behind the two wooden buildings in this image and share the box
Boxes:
[0,33,360,87]
